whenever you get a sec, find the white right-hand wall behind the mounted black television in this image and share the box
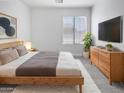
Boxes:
[92,0,124,50]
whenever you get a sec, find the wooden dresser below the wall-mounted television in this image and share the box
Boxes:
[90,46,124,85]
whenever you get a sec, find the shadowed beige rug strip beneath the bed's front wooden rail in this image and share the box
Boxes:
[12,85,79,93]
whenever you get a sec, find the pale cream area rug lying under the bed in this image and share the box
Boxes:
[12,60,101,93]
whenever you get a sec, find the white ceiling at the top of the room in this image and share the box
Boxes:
[22,0,98,7]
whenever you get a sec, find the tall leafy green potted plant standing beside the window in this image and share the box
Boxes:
[83,32,92,58]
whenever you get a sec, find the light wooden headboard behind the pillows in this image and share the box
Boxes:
[0,41,23,50]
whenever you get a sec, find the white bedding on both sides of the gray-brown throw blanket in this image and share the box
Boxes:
[0,52,81,77]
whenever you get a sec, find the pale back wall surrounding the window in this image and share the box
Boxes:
[32,8,91,55]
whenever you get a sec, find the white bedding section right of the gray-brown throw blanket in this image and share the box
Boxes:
[56,52,81,76]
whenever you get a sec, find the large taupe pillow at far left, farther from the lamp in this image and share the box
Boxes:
[0,49,19,65]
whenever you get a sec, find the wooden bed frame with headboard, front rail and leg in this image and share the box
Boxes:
[0,41,84,93]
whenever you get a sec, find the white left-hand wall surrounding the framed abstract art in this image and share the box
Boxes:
[0,0,31,42]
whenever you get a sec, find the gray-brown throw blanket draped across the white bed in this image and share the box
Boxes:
[16,52,58,76]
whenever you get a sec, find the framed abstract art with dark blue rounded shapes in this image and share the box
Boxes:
[0,13,17,39]
